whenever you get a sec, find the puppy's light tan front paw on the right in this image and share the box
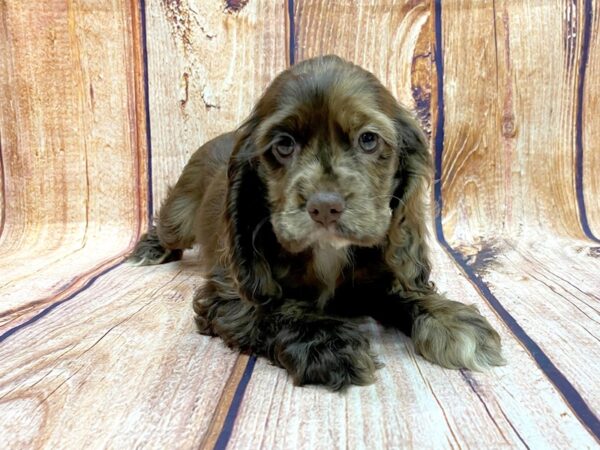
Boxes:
[412,300,505,371]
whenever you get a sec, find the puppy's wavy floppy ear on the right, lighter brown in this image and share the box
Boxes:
[385,106,433,291]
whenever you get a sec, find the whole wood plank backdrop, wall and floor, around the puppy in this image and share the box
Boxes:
[0,0,600,450]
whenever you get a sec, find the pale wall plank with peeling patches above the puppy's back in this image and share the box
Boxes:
[146,0,287,211]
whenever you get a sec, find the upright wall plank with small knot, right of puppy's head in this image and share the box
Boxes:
[442,1,583,240]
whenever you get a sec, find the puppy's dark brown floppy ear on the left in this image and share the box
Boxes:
[225,124,281,304]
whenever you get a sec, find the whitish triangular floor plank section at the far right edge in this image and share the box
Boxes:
[465,238,600,415]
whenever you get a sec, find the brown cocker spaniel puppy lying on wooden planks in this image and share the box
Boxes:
[131,56,503,390]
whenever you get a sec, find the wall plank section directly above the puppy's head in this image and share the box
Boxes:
[295,0,431,118]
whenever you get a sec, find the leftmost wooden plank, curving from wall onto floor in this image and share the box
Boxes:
[0,1,147,320]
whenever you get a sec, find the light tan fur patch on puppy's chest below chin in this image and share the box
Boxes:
[312,245,349,308]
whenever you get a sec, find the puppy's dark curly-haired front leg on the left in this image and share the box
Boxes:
[194,274,378,391]
